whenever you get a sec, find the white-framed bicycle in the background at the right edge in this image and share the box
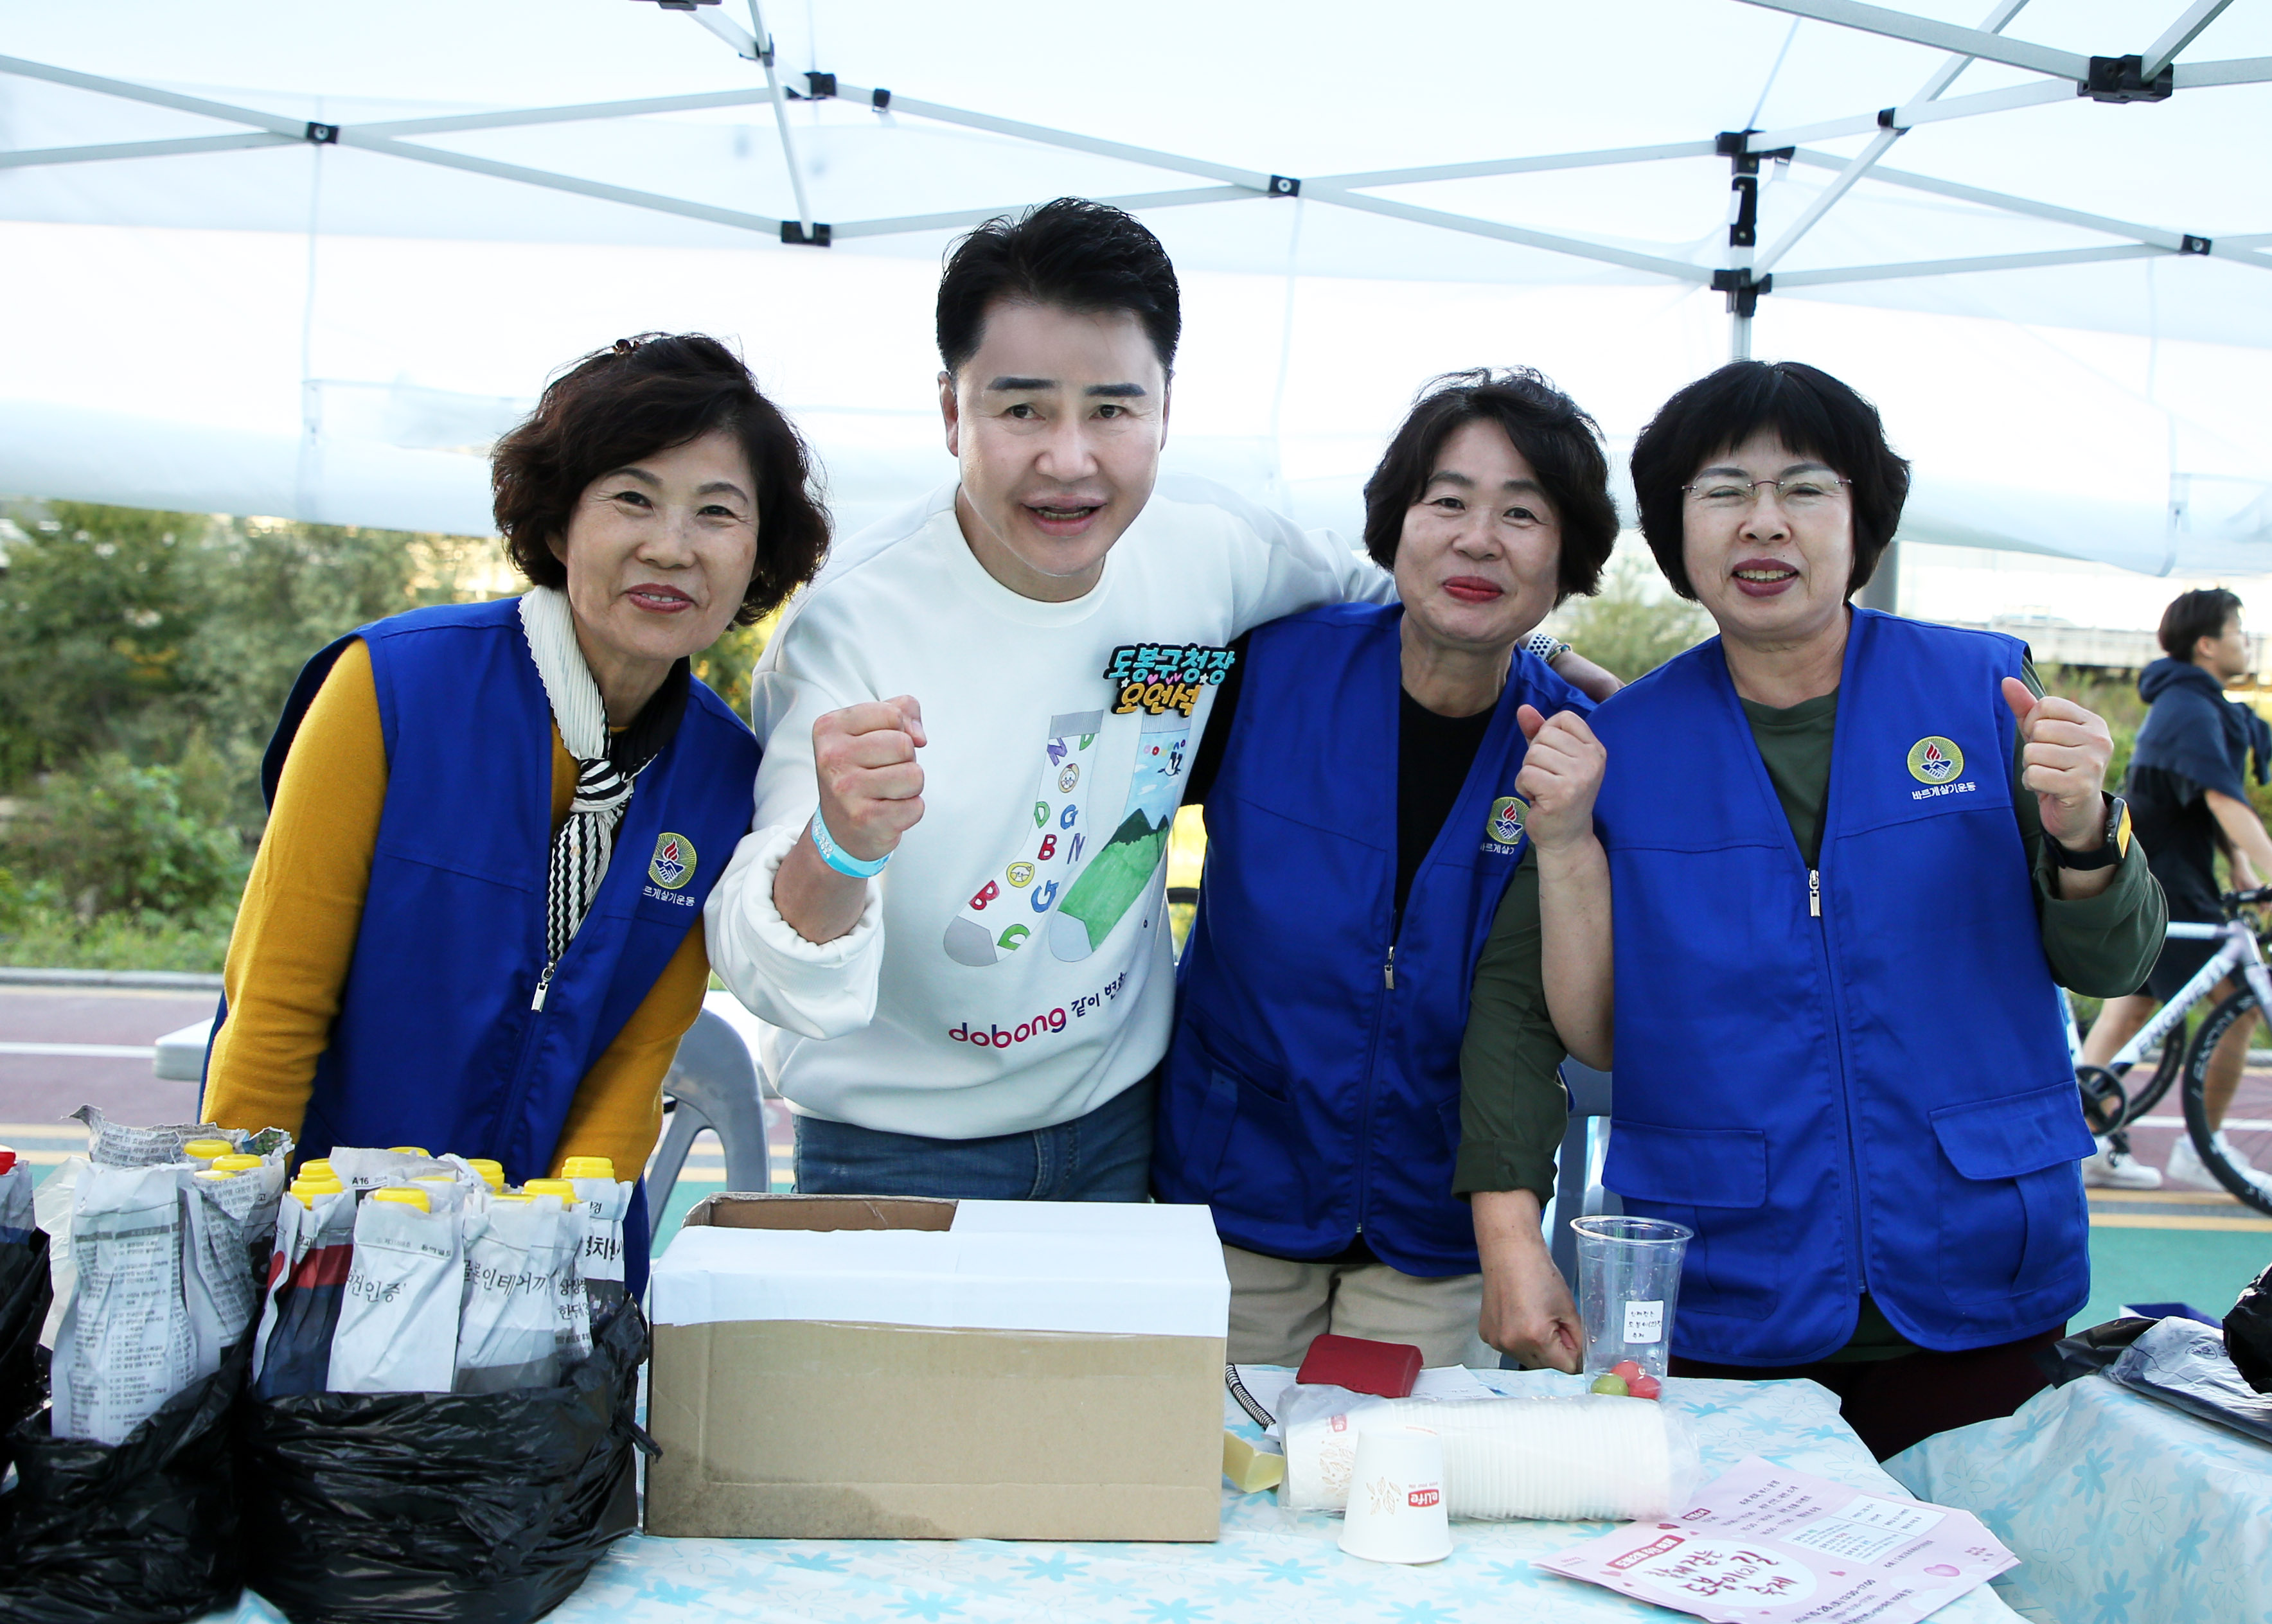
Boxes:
[2074,886,2272,1213]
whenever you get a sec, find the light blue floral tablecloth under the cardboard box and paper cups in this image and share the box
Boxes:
[221,1372,2017,1624]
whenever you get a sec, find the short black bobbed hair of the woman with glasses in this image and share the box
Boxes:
[1633,361,1908,599]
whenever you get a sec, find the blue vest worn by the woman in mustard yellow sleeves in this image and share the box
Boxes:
[216,597,759,1293]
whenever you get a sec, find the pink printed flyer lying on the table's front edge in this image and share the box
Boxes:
[1538,1456,2020,1624]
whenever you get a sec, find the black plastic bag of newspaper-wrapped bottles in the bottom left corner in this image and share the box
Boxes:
[0,1331,250,1624]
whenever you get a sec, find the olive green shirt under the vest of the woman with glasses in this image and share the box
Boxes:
[1452,663,2167,1299]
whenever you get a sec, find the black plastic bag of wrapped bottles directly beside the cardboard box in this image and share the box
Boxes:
[243,1302,654,1624]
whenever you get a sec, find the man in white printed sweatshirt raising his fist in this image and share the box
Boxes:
[704,200,1393,1201]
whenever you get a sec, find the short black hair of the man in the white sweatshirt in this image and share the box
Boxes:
[938,198,1184,373]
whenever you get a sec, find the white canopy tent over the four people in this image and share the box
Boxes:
[0,0,2272,572]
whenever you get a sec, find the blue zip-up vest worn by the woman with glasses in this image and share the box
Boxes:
[1590,609,2093,1365]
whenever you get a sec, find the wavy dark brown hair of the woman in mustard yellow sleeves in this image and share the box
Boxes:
[488,331,830,627]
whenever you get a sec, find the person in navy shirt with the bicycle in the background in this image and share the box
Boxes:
[2084,586,2272,1190]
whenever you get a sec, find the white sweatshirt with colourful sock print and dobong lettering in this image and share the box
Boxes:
[704,477,1395,1138]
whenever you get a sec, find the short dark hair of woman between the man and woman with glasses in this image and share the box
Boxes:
[1365,366,1618,602]
